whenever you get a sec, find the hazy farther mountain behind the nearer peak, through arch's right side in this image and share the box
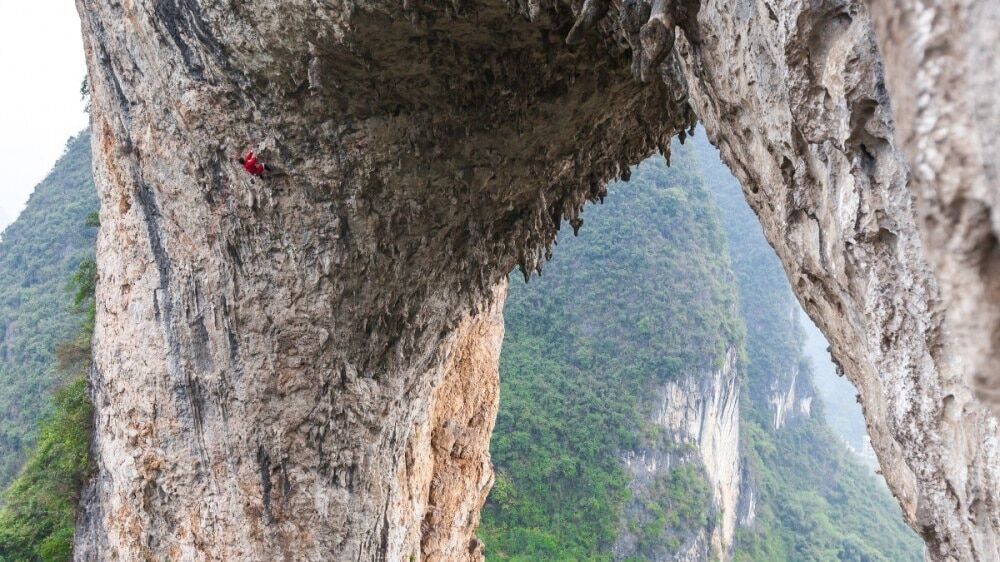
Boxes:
[693,130,923,562]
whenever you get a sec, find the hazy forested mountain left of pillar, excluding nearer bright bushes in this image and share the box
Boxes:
[0,132,98,486]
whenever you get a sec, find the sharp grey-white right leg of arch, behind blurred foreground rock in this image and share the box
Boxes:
[681,0,1000,561]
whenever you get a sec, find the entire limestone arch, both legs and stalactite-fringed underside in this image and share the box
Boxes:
[75,0,1000,561]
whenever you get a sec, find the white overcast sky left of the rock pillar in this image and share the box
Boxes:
[0,0,87,227]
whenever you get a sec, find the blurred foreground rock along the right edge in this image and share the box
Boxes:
[869,0,1000,414]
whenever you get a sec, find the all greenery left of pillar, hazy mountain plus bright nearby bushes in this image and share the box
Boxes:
[0,133,97,562]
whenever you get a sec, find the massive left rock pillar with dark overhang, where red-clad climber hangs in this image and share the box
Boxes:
[76,0,694,561]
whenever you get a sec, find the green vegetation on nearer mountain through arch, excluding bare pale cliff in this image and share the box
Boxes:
[480,150,742,561]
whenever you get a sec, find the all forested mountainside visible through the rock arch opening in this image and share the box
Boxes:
[480,140,921,562]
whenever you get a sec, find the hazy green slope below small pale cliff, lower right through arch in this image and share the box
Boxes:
[734,411,923,562]
